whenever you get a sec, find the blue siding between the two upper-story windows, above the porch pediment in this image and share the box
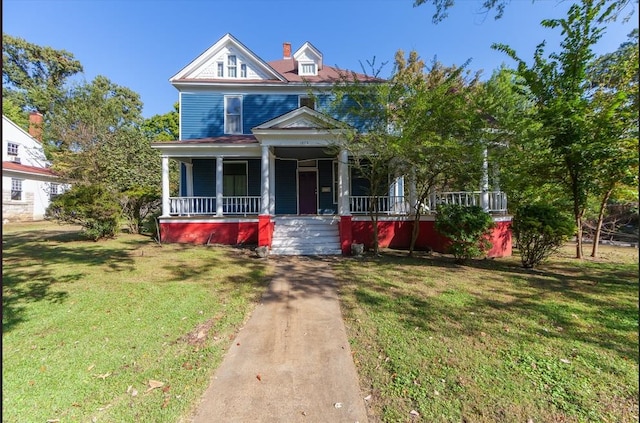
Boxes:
[242,94,298,129]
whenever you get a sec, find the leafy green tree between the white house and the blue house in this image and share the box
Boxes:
[47,76,161,232]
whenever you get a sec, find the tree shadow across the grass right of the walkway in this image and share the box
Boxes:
[343,252,638,362]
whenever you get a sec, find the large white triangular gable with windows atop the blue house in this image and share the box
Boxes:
[169,34,285,83]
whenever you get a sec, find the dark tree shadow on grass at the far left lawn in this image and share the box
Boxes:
[2,229,133,332]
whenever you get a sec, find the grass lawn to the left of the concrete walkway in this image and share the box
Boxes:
[2,223,269,423]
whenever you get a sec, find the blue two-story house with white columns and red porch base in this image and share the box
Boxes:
[153,34,511,256]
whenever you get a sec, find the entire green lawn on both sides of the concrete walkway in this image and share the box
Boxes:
[2,224,638,423]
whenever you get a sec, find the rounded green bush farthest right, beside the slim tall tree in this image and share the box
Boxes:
[511,204,575,269]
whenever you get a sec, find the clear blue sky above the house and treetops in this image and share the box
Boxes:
[2,0,638,117]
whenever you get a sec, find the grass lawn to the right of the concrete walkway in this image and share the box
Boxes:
[337,246,638,423]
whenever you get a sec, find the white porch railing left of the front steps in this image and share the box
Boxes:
[169,196,261,216]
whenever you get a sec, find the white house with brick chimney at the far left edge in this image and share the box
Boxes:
[2,112,66,223]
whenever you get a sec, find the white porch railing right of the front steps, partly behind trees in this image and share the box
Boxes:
[349,191,507,215]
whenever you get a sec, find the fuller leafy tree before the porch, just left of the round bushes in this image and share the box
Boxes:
[392,50,484,256]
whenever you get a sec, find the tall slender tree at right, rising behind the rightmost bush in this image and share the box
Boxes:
[493,0,613,258]
